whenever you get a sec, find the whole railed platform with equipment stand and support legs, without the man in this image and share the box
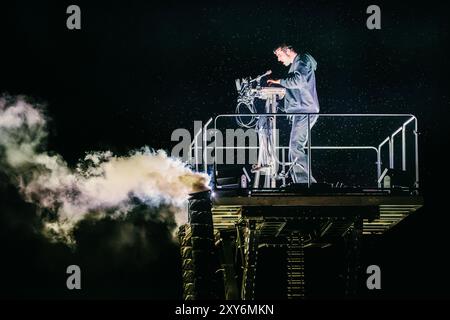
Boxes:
[179,101,424,300]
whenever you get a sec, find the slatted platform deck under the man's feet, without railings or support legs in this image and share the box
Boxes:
[212,189,423,238]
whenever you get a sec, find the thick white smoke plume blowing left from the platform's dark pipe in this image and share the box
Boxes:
[0,97,209,240]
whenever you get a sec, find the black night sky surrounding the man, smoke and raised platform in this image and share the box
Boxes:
[0,1,450,299]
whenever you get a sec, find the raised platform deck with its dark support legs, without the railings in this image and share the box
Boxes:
[179,186,423,300]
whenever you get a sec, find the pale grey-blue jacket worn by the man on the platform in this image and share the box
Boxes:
[280,54,320,113]
